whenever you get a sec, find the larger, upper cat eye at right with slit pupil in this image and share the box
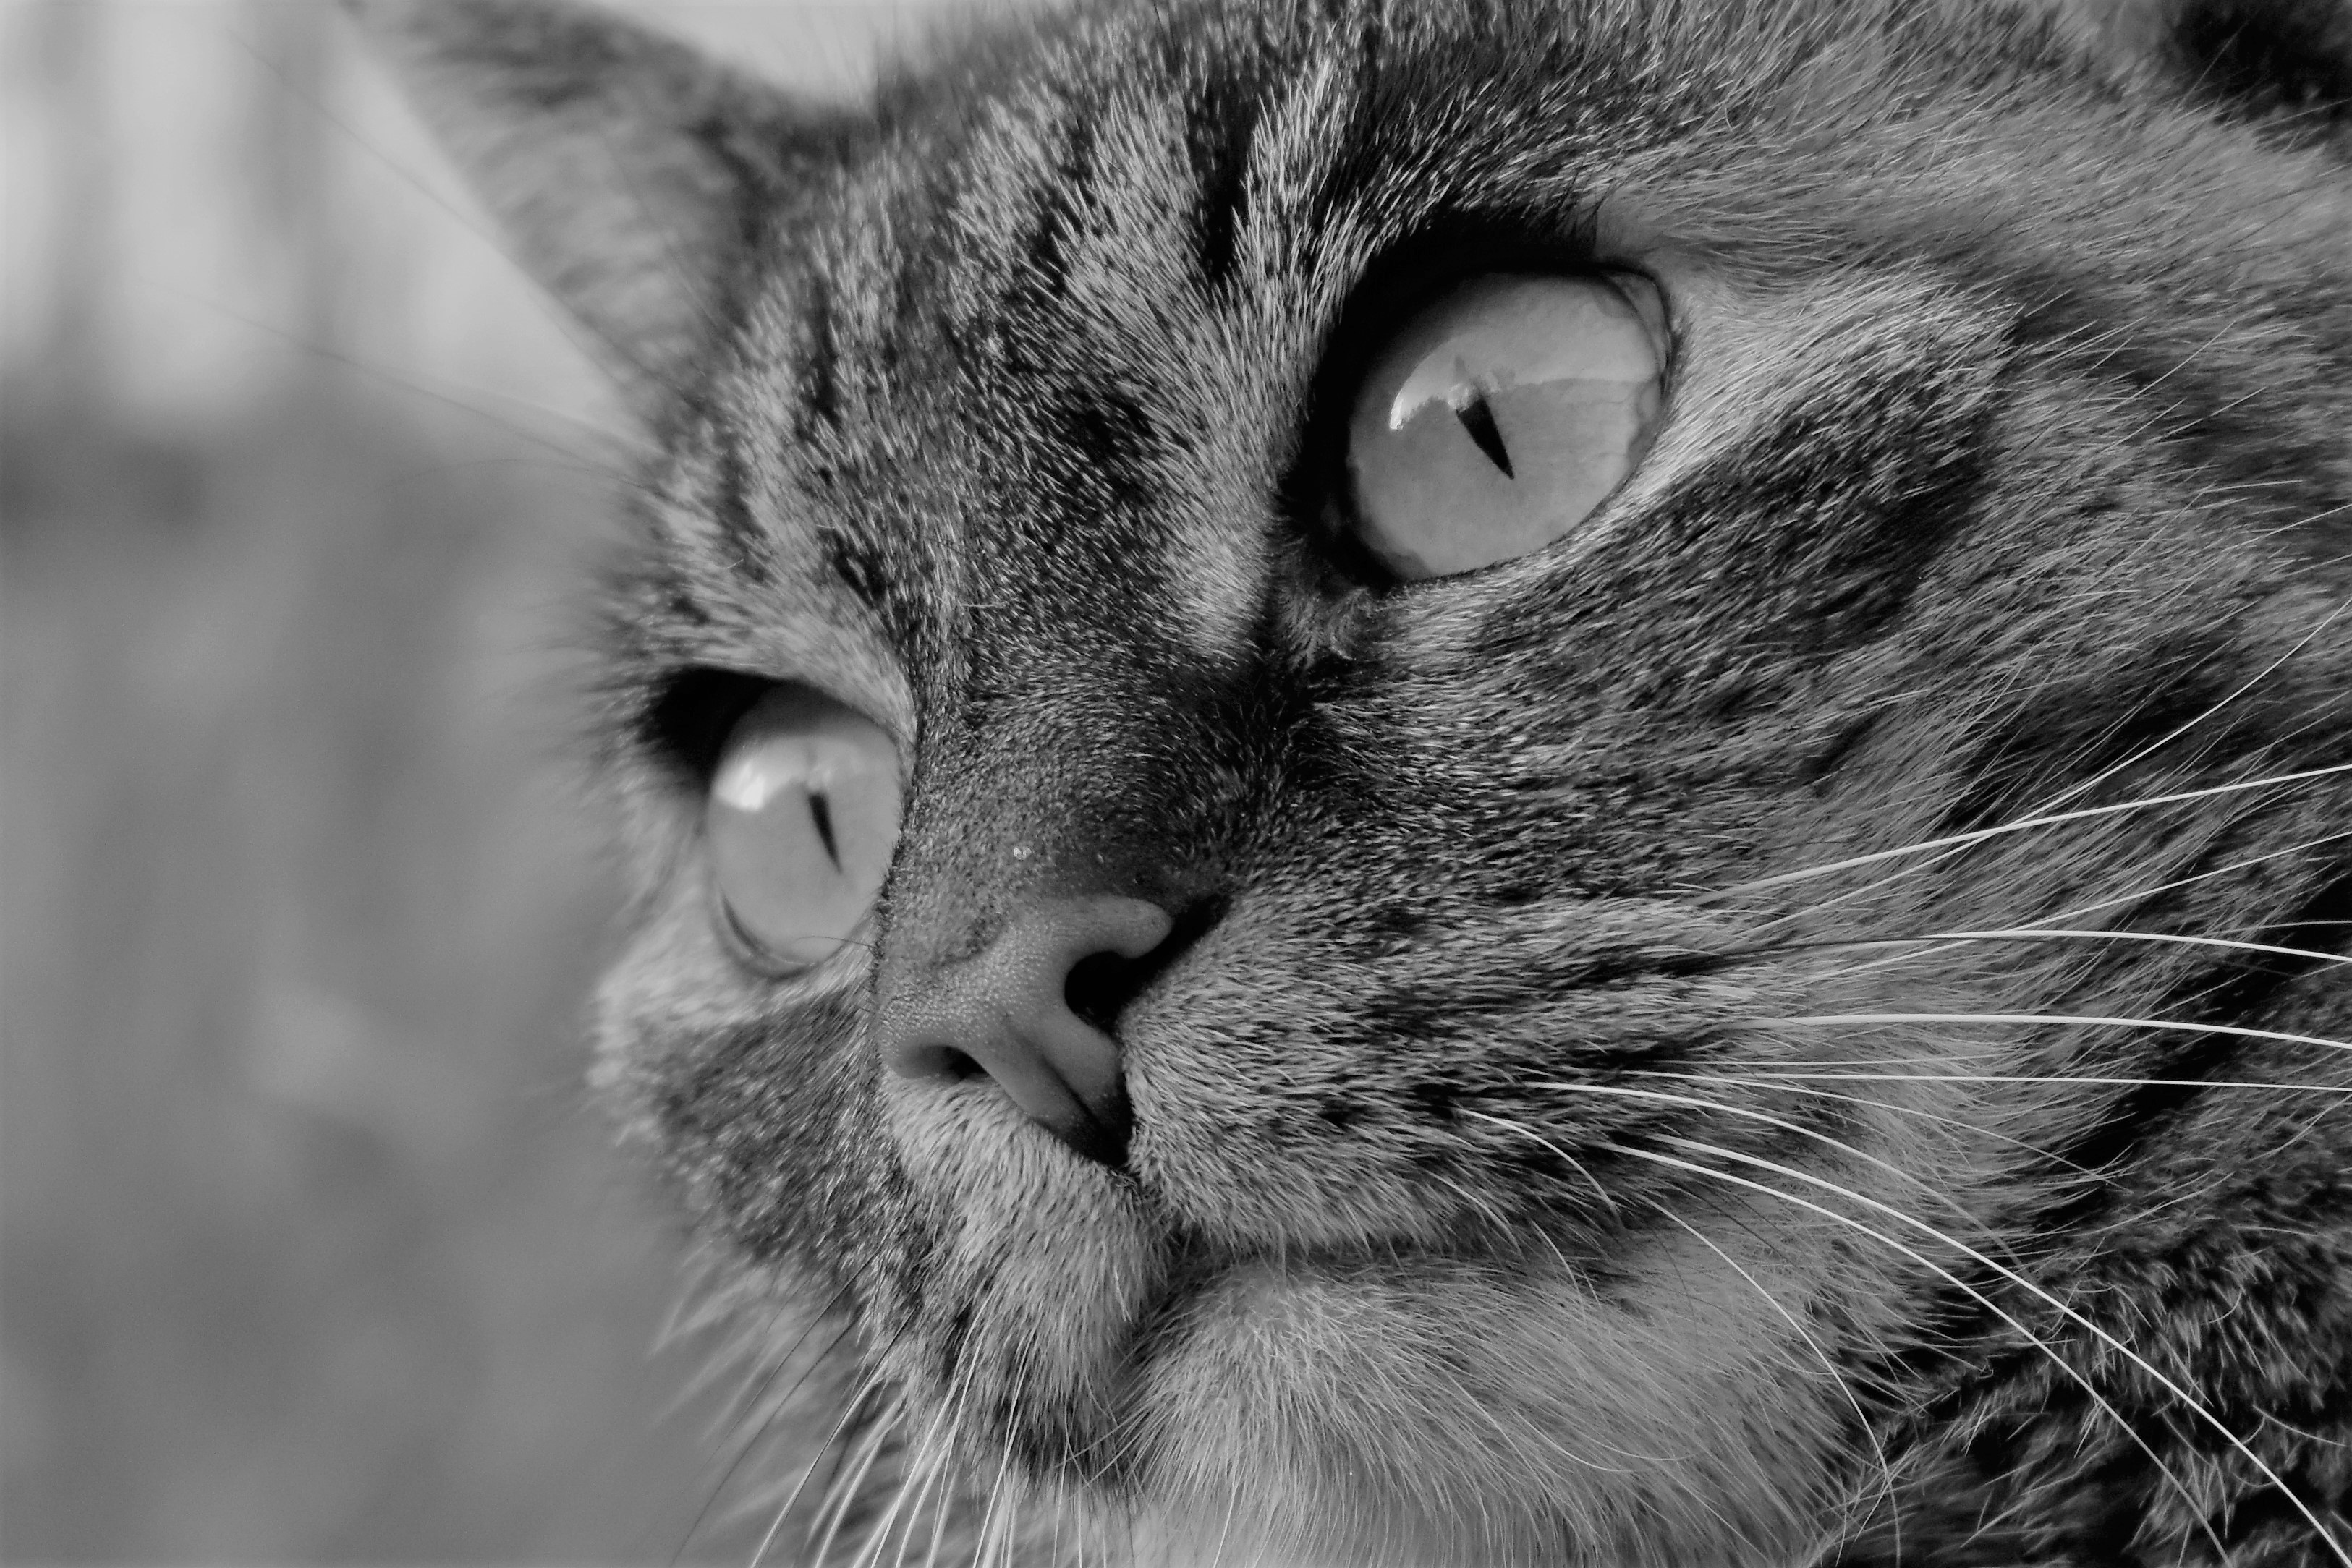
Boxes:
[1348,273,1665,579]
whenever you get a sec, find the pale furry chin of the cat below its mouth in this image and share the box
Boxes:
[1105,1239,1839,1568]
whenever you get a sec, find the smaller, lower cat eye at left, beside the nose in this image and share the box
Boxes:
[703,686,899,968]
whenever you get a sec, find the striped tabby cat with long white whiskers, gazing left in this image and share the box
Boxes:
[357,0,2352,1568]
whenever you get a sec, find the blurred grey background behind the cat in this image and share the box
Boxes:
[0,0,955,1563]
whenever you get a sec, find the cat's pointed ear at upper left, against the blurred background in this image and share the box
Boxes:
[346,0,844,419]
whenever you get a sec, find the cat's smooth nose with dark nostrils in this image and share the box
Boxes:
[875,893,1176,1166]
